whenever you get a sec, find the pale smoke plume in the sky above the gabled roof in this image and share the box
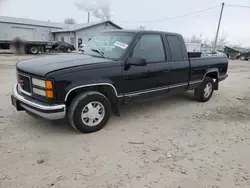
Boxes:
[75,0,111,20]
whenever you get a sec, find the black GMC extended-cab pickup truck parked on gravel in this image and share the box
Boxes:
[11,30,228,133]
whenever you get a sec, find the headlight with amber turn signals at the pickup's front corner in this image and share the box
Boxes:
[32,78,54,98]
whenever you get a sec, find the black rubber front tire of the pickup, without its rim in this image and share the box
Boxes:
[67,91,111,133]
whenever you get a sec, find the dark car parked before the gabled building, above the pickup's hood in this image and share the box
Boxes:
[46,41,75,53]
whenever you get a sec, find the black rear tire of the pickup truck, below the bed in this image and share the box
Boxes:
[195,77,214,102]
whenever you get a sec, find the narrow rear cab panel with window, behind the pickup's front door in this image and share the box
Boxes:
[165,34,190,90]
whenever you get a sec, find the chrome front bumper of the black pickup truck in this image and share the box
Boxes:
[11,84,66,120]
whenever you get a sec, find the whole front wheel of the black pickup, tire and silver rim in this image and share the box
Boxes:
[68,91,111,133]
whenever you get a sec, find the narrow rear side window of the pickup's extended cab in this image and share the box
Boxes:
[167,35,183,61]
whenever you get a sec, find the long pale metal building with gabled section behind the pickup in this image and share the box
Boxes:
[0,16,122,49]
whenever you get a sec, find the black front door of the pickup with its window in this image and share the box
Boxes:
[123,33,169,95]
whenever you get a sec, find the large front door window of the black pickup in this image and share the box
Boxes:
[133,35,166,62]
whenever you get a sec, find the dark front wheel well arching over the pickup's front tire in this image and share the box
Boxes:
[66,85,120,115]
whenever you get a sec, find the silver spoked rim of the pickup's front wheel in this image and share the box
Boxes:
[81,101,105,127]
